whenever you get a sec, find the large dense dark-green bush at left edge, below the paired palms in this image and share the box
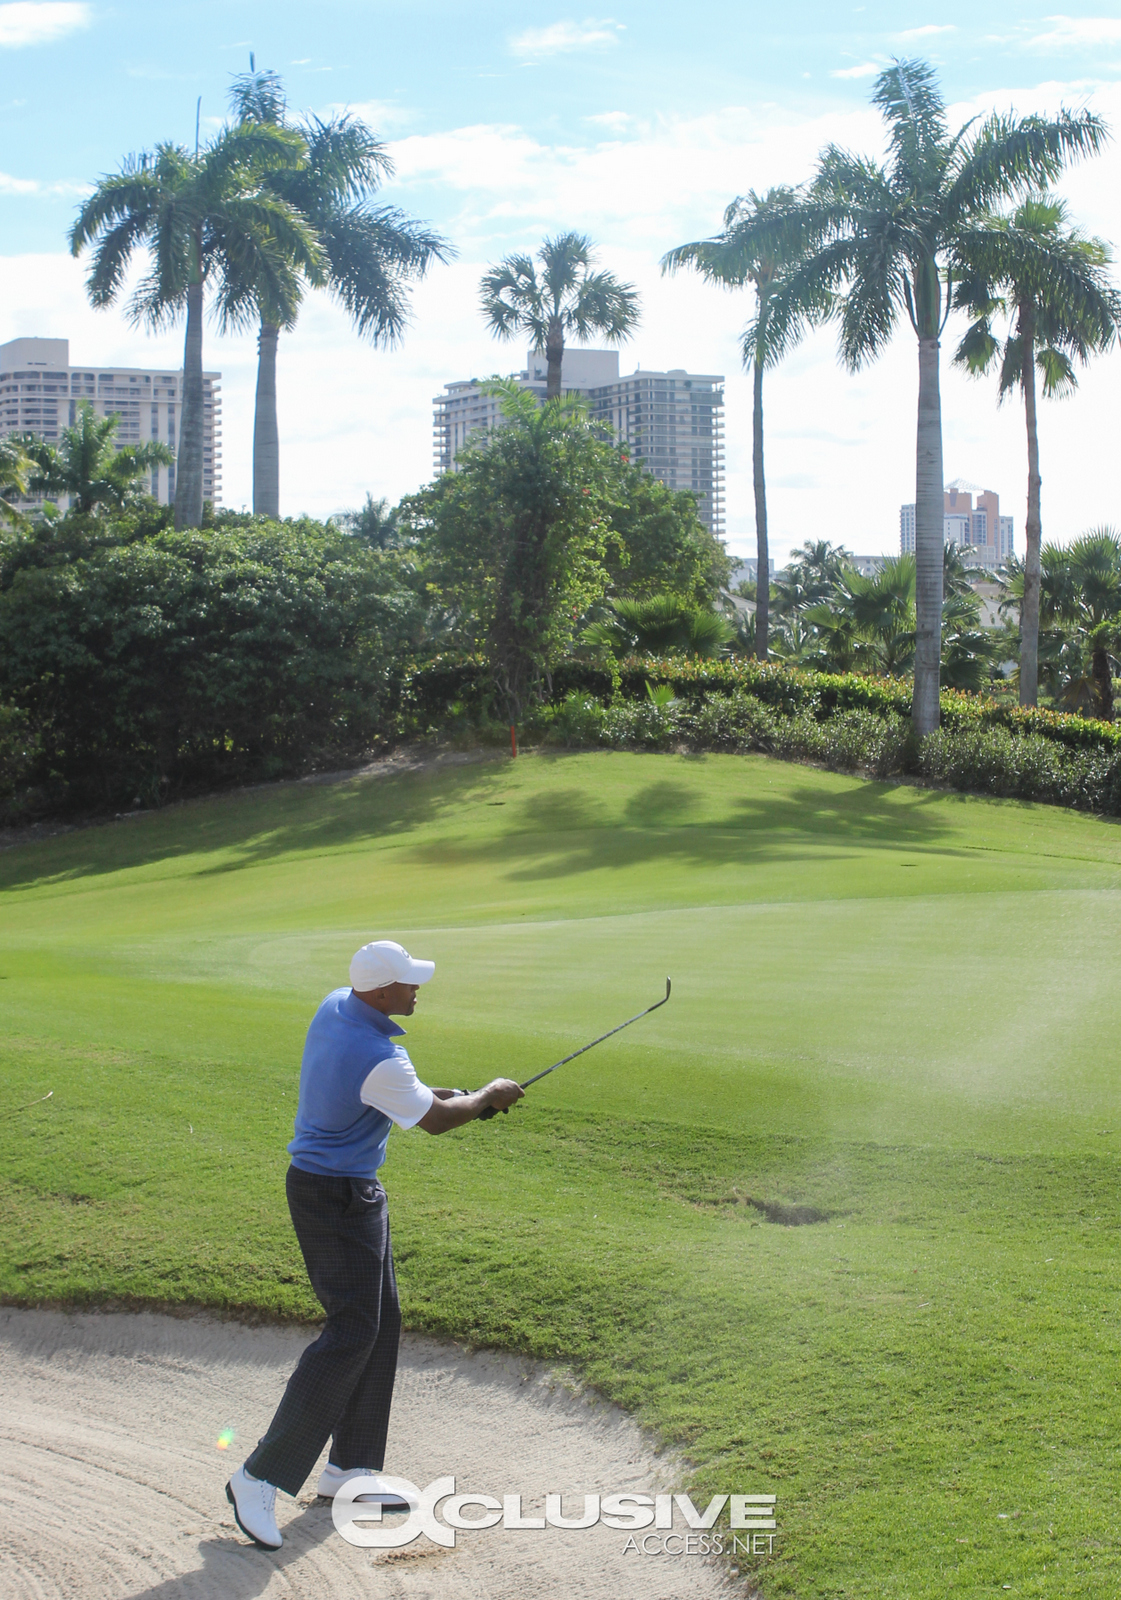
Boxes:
[0,514,417,808]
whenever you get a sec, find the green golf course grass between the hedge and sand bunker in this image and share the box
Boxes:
[0,752,1121,1600]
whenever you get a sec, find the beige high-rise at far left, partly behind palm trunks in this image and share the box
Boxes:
[0,339,222,506]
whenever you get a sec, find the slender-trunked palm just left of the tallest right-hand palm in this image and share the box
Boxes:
[662,187,830,661]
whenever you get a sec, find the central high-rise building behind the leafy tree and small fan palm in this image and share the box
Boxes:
[432,350,724,536]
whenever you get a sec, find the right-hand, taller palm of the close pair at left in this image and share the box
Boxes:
[230,68,454,517]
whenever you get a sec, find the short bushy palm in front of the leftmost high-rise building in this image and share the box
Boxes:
[27,402,174,512]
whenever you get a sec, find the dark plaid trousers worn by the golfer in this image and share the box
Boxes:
[245,1166,401,1494]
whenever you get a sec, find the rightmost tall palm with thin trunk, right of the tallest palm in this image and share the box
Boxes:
[953,194,1121,706]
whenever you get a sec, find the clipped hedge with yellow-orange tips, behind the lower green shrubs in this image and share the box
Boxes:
[406,656,1121,752]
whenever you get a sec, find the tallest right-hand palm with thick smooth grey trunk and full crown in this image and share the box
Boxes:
[771,61,1105,736]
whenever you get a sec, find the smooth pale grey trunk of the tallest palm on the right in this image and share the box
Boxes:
[912,334,943,738]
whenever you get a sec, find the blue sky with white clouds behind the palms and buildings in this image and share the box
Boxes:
[0,0,1121,552]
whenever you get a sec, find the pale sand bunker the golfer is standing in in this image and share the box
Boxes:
[0,1310,744,1600]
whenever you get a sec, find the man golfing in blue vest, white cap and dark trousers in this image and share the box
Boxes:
[225,939,523,1550]
